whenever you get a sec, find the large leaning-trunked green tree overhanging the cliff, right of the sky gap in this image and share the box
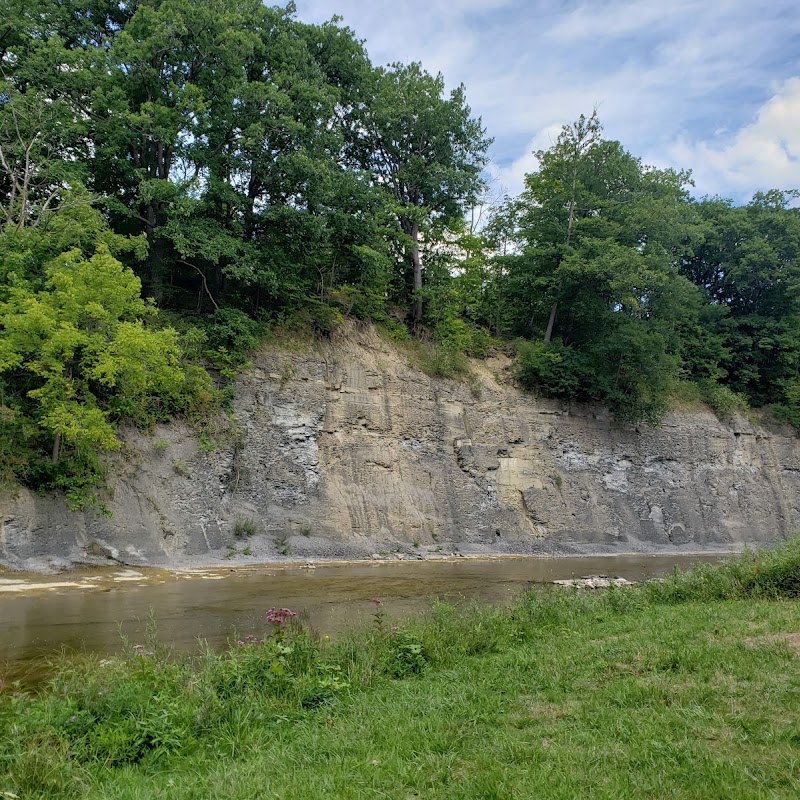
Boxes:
[508,115,699,422]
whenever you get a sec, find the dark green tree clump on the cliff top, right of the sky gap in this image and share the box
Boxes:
[500,115,800,432]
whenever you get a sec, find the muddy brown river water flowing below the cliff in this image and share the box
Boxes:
[0,554,724,683]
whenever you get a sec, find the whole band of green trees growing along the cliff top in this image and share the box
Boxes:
[0,0,800,506]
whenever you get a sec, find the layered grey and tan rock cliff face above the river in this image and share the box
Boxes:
[0,329,800,569]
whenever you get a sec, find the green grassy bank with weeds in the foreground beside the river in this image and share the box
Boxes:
[0,540,800,800]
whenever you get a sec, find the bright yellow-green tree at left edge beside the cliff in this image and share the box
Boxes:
[0,245,209,506]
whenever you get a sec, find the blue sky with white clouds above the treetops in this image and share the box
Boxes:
[296,0,800,203]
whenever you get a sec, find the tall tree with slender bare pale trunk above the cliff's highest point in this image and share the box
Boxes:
[360,63,492,322]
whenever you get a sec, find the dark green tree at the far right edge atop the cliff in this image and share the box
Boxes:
[681,190,800,424]
